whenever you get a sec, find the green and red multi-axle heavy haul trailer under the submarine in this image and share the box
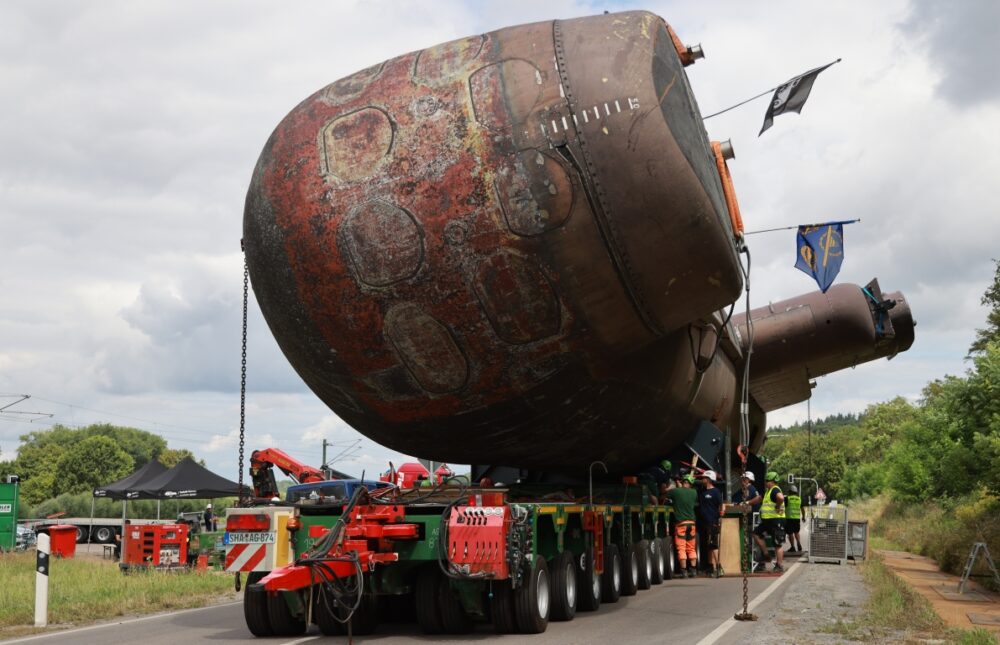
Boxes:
[227,478,673,636]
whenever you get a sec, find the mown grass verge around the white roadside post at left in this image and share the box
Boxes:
[0,552,233,639]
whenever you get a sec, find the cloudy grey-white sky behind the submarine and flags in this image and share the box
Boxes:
[0,0,1000,478]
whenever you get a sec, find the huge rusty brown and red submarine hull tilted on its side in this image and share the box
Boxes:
[244,12,913,472]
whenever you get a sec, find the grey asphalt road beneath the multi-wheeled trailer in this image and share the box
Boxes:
[1,559,809,645]
